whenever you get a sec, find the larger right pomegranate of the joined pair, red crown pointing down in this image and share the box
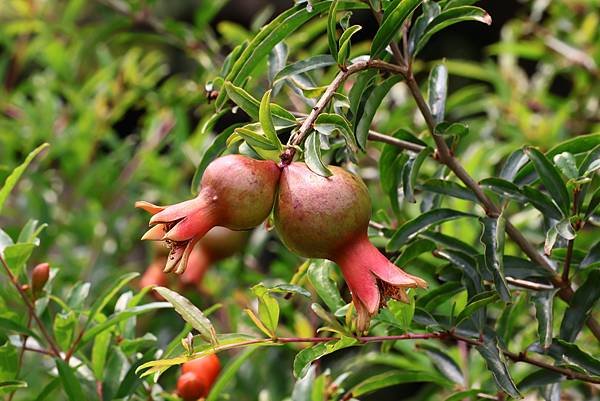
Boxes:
[274,163,427,331]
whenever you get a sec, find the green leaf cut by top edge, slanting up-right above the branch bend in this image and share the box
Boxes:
[371,0,423,58]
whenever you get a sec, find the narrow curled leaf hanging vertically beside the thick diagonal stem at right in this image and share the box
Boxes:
[480,216,510,302]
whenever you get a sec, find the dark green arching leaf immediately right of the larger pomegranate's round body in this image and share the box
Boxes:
[386,209,475,251]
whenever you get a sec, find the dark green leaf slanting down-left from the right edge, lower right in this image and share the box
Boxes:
[560,270,600,341]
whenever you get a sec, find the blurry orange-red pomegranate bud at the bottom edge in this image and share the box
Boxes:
[177,354,221,401]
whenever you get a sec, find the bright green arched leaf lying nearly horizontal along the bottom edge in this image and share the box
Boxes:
[350,370,450,397]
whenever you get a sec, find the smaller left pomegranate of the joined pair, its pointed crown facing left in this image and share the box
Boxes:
[135,155,281,274]
